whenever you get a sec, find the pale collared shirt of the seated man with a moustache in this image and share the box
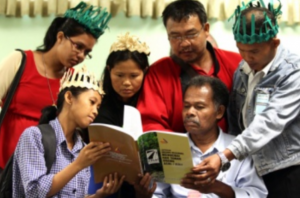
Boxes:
[153,129,267,198]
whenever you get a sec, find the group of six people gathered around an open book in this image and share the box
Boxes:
[0,0,300,198]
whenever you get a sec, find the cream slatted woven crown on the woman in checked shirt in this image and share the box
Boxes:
[59,66,105,96]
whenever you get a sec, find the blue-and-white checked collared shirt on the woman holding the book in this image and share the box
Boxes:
[13,118,90,198]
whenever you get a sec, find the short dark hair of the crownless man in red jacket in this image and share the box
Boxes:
[162,0,207,27]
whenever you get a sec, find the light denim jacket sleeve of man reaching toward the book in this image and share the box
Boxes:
[229,69,300,160]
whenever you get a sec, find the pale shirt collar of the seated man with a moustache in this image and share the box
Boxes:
[188,127,226,156]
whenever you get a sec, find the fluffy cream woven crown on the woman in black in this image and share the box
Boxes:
[110,32,150,56]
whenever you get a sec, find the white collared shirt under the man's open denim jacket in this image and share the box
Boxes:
[242,58,274,127]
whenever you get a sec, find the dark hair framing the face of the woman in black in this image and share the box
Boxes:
[102,50,149,103]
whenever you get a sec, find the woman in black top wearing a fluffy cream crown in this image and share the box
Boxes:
[89,33,156,198]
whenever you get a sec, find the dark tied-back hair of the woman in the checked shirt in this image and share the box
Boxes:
[39,86,88,124]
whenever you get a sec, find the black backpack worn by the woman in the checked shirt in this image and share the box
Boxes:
[0,124,56,198]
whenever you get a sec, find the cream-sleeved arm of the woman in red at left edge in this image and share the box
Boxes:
[0,51,22,99]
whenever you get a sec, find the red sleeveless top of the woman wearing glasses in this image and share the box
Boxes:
[0,51,60,168]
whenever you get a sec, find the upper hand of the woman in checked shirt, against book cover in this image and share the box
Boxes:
[74,142,111,170]
